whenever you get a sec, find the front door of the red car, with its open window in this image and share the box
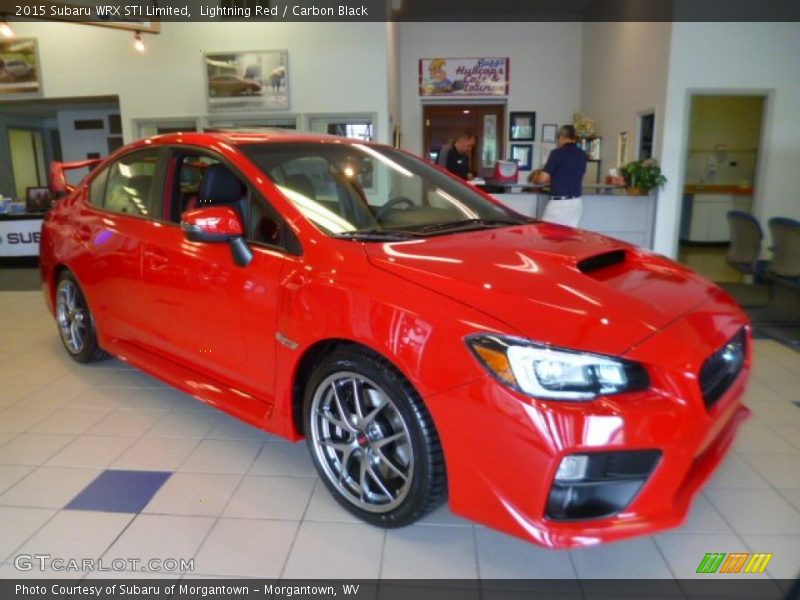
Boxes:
[142,148,289,404]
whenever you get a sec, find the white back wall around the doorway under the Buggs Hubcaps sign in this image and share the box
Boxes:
[399,23,582,165]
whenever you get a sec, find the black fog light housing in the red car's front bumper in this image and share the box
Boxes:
[545,450,661,521]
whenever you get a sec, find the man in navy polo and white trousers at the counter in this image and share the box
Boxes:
[531,125,587,227]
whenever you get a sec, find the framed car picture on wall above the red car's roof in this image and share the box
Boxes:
[203,50,289,111]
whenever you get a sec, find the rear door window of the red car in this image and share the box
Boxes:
[103,150,161,218]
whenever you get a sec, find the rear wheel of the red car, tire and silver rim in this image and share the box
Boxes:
[55,271,108,363]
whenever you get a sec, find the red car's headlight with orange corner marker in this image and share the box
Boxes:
[467,335,650,401]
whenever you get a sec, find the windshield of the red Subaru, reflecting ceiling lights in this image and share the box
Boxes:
[240,143,527,239]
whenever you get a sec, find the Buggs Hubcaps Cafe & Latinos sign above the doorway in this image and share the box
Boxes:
[419,58,509,96]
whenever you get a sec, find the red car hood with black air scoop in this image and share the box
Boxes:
[365,223,730,354]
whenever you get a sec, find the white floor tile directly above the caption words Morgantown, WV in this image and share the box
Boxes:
[282,523,385,579]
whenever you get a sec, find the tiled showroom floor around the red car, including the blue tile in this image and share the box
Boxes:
[0,291,800,597]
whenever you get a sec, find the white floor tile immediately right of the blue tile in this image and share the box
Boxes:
[142,473,241,516]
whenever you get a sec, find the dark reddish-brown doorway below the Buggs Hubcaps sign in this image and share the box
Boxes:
[422,104,505,177]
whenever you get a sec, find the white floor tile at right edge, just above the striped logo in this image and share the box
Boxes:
[705,489,800,535]
